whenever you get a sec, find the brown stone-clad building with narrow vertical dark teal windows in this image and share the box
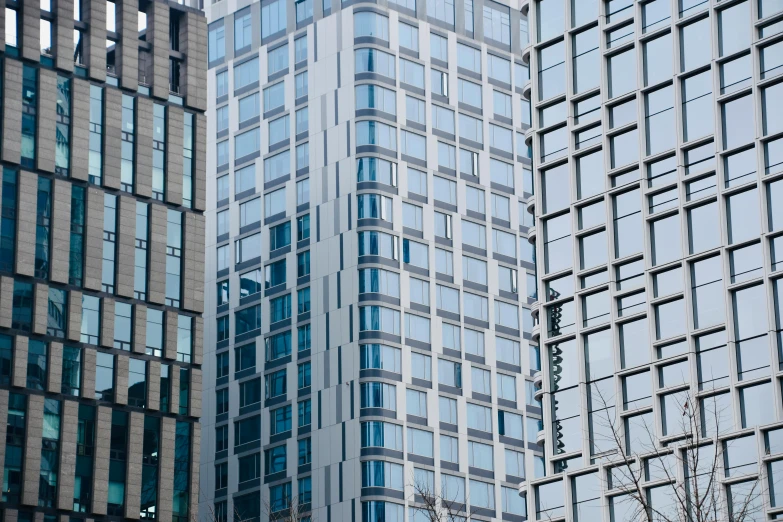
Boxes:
[0,0,207,522]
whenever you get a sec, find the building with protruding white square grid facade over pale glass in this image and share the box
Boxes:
[523,0,783,522]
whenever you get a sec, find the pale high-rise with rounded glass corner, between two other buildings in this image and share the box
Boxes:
[201,0,544,522]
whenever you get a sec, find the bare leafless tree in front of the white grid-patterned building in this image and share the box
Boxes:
[591,387,764,522]
